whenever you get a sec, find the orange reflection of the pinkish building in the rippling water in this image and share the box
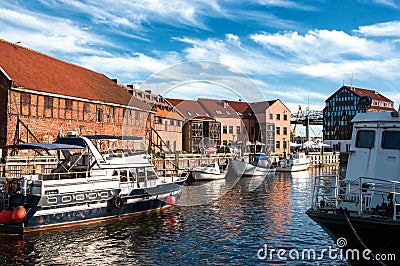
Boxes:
[265,173,292,239]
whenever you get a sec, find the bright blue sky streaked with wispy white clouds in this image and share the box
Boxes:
[0,0,400,112]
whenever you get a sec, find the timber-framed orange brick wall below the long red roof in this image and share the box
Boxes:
[2,90,150,144]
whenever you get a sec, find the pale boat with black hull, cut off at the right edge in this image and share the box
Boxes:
[307,112,400,265]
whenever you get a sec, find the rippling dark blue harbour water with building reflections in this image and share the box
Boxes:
[0,168,344,265]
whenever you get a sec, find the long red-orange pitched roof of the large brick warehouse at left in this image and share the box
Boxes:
[0,39,149,110]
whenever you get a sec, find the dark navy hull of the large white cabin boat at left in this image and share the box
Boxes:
[0,180,184,234]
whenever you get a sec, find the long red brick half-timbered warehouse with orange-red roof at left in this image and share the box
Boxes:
[0,39,153,147]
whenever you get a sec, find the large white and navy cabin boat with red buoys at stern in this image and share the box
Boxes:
[0,136,186,234]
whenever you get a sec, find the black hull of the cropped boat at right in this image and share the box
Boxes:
[306,209,400,265]
